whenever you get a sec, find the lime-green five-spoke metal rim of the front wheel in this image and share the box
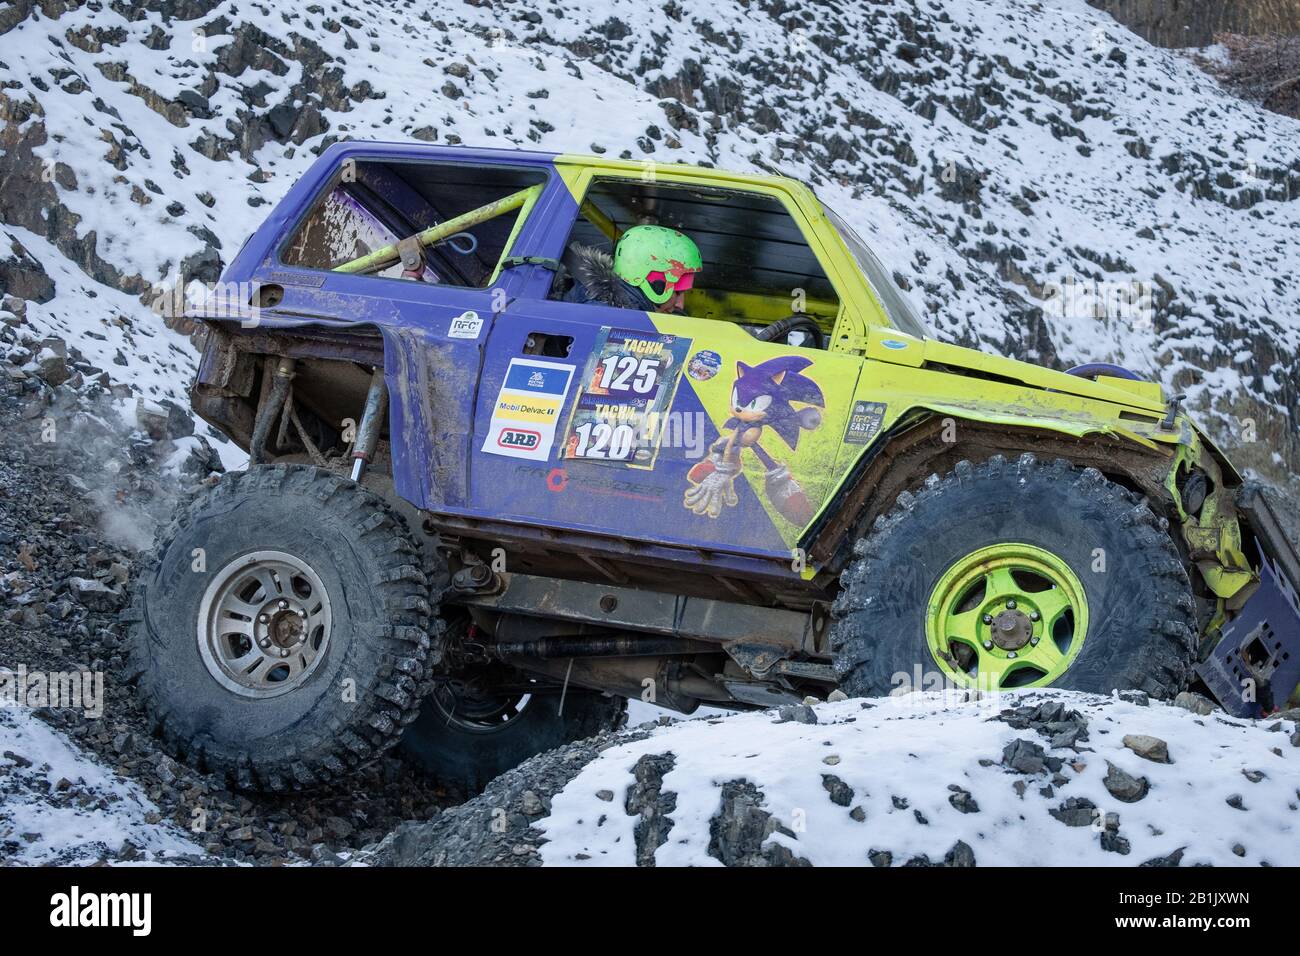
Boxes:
[926,544,1088,691]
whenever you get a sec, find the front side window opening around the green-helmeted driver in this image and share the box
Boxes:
[551,179,840,347]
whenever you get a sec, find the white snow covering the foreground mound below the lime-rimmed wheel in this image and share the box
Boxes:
[540,691,1300,866]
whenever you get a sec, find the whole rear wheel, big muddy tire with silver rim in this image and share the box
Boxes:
[133,464,442,791]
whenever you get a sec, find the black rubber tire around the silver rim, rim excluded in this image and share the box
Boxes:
[131,464,443,792]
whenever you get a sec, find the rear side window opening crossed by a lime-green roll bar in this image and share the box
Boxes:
[280,160,546,289]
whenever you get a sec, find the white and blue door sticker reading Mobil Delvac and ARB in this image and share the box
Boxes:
[482,359,575,462]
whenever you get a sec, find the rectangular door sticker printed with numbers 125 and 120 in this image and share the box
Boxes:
[563,326,690,468]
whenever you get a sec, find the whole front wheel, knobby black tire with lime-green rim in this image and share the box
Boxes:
[831,455,1196,698]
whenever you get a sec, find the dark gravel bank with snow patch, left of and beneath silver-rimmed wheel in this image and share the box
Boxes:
[0,356,454,865]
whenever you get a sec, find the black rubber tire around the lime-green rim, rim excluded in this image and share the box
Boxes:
[831,455,1196,698]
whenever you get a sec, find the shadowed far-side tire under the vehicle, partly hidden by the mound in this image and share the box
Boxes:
[402,688,628,796]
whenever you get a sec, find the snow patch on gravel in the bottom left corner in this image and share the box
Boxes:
[0,706,204,866]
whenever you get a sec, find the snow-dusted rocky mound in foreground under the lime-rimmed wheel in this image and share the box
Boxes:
[350,692,1300,866]
